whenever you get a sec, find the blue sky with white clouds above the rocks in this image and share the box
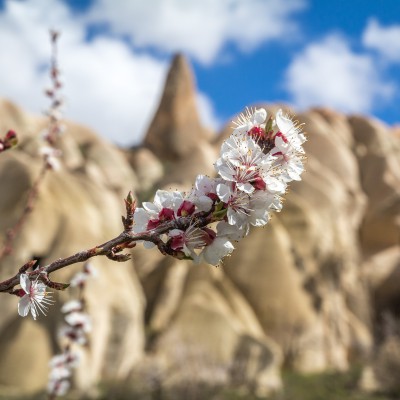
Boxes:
[0,0,400,145]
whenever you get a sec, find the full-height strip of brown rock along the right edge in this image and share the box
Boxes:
[349,116,400,392]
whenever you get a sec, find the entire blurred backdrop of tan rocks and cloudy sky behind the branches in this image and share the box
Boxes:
[0,0,400,400]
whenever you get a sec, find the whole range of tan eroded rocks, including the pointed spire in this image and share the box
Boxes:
[0,56,400,399]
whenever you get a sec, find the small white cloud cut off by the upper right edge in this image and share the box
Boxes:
[362,19,400,62]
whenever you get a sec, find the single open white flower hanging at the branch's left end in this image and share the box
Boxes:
[18,274,53,320]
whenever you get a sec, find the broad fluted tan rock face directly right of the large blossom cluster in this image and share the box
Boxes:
[214,106,372,371]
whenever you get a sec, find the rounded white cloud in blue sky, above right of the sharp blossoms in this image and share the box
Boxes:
[286,35,395,112]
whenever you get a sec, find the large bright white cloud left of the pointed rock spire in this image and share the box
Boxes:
[0,0,167,145]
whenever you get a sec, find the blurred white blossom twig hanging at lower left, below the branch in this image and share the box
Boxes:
[47,263,96,398]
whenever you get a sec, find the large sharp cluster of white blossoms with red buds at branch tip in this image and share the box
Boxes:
[133,109,306,265]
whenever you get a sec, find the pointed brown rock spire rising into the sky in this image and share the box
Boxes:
[144,55,216,189]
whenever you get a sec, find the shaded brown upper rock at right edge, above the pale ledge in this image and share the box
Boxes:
[350,116,400,255]
